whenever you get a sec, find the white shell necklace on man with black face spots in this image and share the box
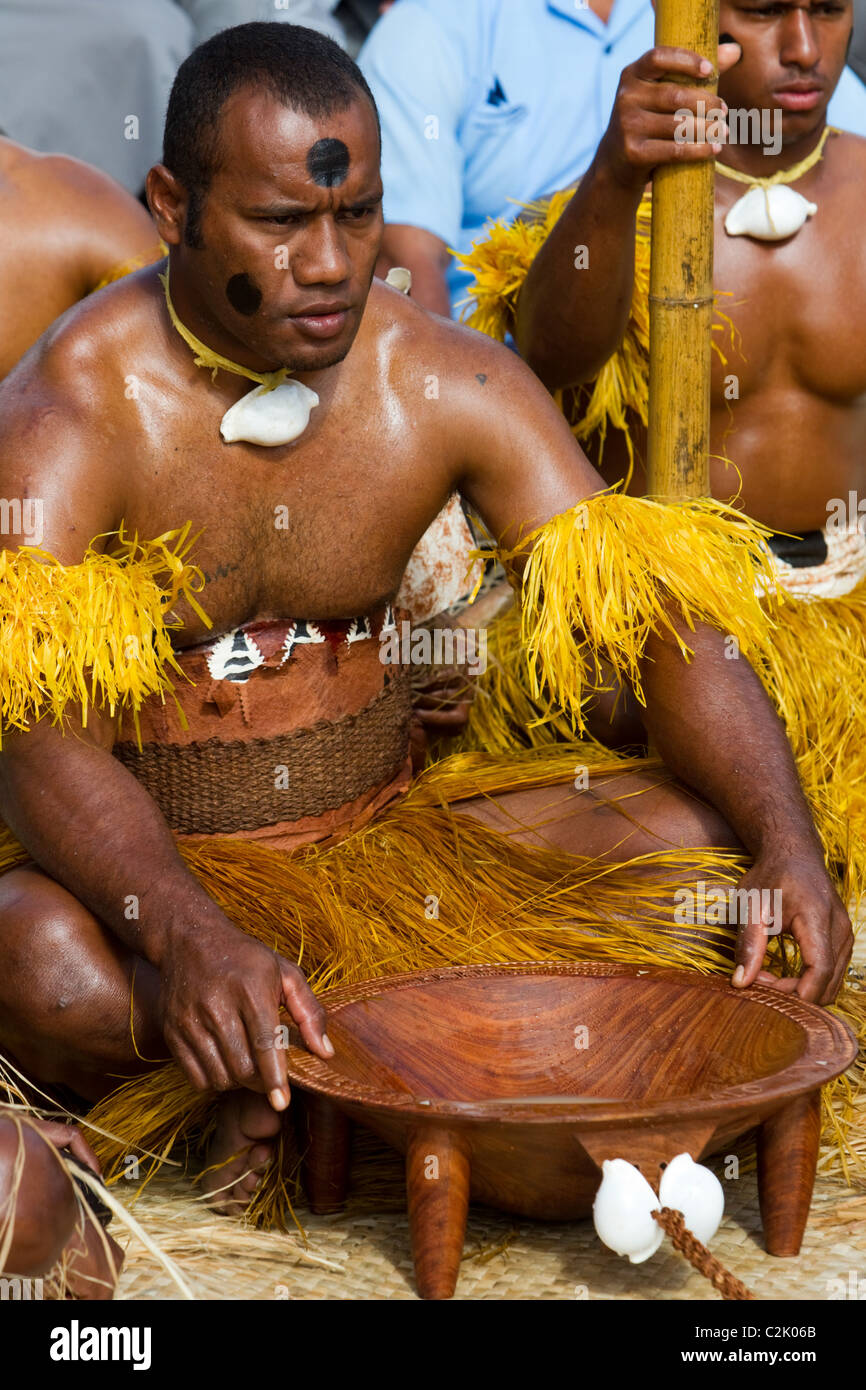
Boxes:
[160,271,318,448]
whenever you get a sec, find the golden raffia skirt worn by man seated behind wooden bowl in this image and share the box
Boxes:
[0,739,866,1226]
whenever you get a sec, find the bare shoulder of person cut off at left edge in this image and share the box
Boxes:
[0,136,158,377]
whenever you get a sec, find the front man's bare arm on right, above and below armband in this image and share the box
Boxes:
[442,341,852,1001]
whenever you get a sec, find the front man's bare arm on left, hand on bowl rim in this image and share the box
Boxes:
[0,341,329,1109]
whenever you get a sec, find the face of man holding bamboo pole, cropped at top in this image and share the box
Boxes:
[719,0,853,143]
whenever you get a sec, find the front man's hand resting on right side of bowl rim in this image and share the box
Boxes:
[733,849,853,1004]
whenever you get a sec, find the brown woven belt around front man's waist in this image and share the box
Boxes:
[114,671,411,835]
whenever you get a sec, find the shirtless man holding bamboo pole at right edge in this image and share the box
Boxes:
[464,0,866,878]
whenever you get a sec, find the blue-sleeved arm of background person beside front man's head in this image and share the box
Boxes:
[359,0,470,316]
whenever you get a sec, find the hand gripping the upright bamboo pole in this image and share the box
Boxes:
[599,43,741,190]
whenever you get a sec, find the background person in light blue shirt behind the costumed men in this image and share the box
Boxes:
[359,0,866,314]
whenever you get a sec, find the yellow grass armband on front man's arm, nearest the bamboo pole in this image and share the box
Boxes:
[499,492,776,728]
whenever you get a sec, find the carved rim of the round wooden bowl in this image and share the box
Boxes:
[286,960,859,1129]
